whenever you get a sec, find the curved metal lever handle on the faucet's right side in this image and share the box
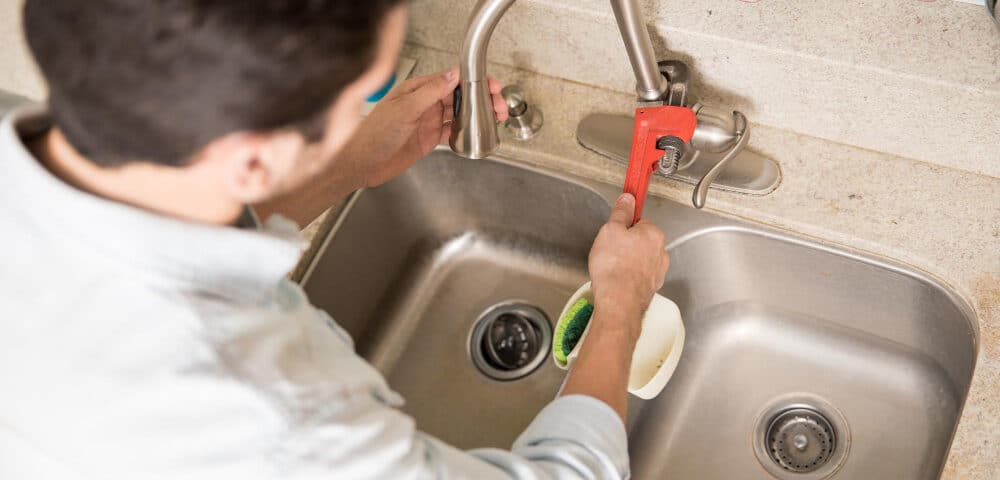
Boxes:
[691,109,750,208]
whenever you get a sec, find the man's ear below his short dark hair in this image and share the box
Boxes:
[206,131,304,204]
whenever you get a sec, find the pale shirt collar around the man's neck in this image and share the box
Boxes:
[0,107,305,303]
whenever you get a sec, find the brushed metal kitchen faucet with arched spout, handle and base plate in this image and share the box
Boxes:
[449,0,780,208]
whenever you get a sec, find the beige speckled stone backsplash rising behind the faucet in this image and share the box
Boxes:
[409,0,1000,177]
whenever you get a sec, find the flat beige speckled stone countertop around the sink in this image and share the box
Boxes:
[304,45,1000,480]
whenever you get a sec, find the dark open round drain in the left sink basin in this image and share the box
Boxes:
[469,302,552,380]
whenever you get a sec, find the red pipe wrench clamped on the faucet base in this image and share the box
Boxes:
[625,106,698,225]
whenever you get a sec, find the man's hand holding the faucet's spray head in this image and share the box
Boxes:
[341,67,507,187]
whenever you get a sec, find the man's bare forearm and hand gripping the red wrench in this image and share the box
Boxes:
[562,194,670,421]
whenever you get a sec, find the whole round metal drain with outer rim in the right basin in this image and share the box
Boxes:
[754,393,851,480]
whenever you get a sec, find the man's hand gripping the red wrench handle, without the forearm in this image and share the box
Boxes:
[589,194,670,344]
